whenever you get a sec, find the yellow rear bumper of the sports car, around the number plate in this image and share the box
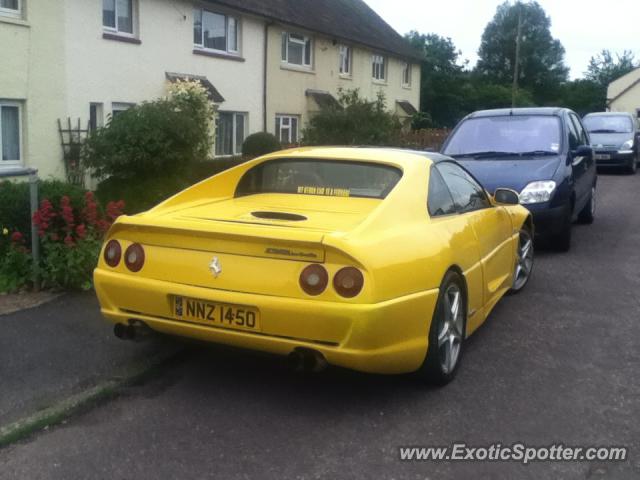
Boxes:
[94,269,438,374]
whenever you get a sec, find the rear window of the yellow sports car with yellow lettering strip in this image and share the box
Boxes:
[236,159,402,199]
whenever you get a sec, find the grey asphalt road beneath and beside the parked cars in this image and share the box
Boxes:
[0,175,640,480]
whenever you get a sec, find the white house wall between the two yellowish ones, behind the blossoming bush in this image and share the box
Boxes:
[66,0,264,141]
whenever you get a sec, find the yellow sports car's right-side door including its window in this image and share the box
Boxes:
[437,162,515,307]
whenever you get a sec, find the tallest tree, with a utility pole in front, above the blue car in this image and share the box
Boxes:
[476,1,569,105]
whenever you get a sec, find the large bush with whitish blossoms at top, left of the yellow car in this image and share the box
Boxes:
[82,82,213,179]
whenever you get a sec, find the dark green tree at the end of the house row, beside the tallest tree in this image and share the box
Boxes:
[406,31,467,127]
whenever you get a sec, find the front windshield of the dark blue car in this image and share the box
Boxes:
[444,115,561,155]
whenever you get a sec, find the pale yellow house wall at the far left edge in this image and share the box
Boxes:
[0,1,66,178]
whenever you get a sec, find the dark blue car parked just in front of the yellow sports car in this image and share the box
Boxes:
[442,108,597,251]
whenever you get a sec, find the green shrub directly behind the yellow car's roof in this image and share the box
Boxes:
[303,89,402,145]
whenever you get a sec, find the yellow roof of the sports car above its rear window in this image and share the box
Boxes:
[263,147,451,167]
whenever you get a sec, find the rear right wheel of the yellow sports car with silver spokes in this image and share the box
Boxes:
[418,271,467,386]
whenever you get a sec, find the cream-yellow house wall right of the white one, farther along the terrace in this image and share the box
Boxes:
[267,25,420,138]
